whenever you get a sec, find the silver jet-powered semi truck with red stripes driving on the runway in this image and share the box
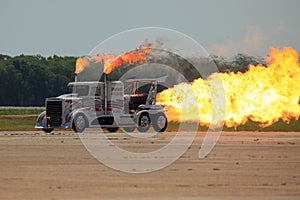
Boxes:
[35,75,168,133]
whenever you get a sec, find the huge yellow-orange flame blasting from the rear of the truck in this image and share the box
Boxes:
[157,47,300,127]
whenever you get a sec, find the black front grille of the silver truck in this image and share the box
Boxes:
[46,99,62,127]
